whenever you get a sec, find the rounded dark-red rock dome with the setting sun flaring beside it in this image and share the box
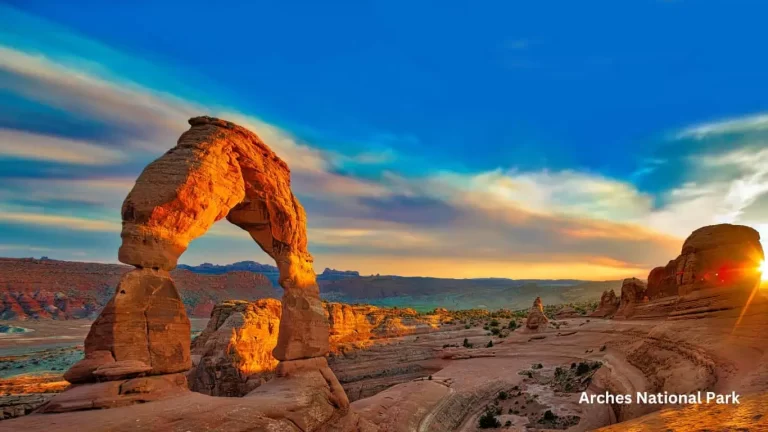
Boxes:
[648,224,765,300]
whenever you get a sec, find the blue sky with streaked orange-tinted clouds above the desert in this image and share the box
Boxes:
[0,0,768,279]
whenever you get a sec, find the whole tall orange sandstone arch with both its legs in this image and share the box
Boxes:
[72,117,329,382]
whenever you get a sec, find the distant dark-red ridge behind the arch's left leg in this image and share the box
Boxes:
[0,258,278,320]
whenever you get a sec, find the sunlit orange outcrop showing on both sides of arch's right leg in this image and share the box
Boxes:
[187,299,452,396]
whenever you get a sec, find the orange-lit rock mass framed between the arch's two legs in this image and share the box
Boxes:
[187,299,282,396]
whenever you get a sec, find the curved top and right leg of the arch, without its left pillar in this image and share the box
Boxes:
[118,117,328,360]
